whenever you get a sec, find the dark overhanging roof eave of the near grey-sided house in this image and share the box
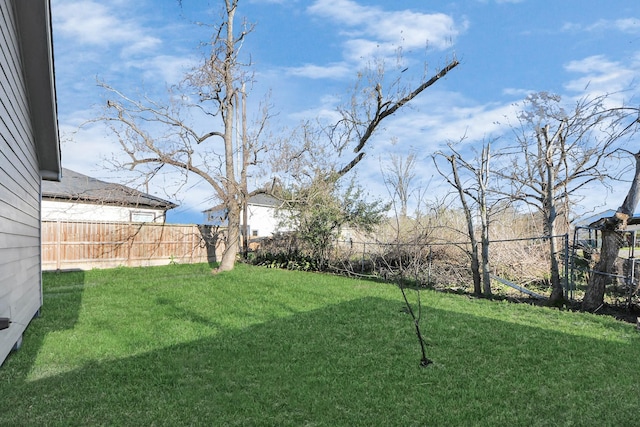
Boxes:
[12,0,61,180]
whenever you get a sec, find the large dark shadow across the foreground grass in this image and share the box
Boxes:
[0,297,640,426]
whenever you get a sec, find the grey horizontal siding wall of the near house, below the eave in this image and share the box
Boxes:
[0,0,42,364]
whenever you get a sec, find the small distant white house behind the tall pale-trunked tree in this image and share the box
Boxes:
[204,194,282,238]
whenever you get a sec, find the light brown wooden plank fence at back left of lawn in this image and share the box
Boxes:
[42,221,224,270]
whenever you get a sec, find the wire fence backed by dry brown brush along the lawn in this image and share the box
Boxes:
[252,235,572,297]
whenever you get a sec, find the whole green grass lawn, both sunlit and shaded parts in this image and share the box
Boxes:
[0,265,640,426]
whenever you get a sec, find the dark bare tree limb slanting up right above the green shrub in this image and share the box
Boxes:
[274,55,459,191]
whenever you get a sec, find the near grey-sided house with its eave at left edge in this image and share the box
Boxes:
[0,0,60,364]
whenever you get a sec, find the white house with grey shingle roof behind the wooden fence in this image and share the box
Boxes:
[42,168,176,223]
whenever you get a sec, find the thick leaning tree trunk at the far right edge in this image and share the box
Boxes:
[582,150,640,311]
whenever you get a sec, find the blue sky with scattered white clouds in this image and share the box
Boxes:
[52,0,640,223]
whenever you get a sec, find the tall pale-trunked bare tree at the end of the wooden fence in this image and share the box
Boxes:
[100,0,268,271]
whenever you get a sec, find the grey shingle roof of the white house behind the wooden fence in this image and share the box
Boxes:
[42,168,177,210]
